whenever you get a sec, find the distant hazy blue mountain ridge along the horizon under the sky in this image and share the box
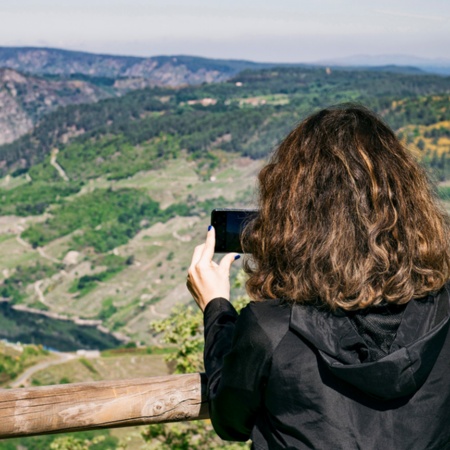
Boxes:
[0,47,450,78]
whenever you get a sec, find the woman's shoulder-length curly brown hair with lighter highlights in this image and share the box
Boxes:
[243,104,450,310]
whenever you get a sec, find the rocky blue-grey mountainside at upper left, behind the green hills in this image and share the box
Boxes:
[0,47,306,145]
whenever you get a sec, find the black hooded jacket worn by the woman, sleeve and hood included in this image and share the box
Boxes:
[204,285,450,450]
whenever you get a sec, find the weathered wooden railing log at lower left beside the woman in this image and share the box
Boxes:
[0,373,208,438]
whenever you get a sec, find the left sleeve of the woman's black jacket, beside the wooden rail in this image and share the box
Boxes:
[204,298,271,441]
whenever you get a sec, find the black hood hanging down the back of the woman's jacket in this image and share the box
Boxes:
[290,284,450,400]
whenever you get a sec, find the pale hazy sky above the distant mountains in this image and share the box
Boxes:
[0,0,450,62]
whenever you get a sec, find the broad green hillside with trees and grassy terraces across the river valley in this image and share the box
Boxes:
[0,67,450,341]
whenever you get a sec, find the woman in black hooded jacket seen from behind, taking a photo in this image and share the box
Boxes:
[187,105,450,450]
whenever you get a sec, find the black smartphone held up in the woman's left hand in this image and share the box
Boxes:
[211,208,258,253]
